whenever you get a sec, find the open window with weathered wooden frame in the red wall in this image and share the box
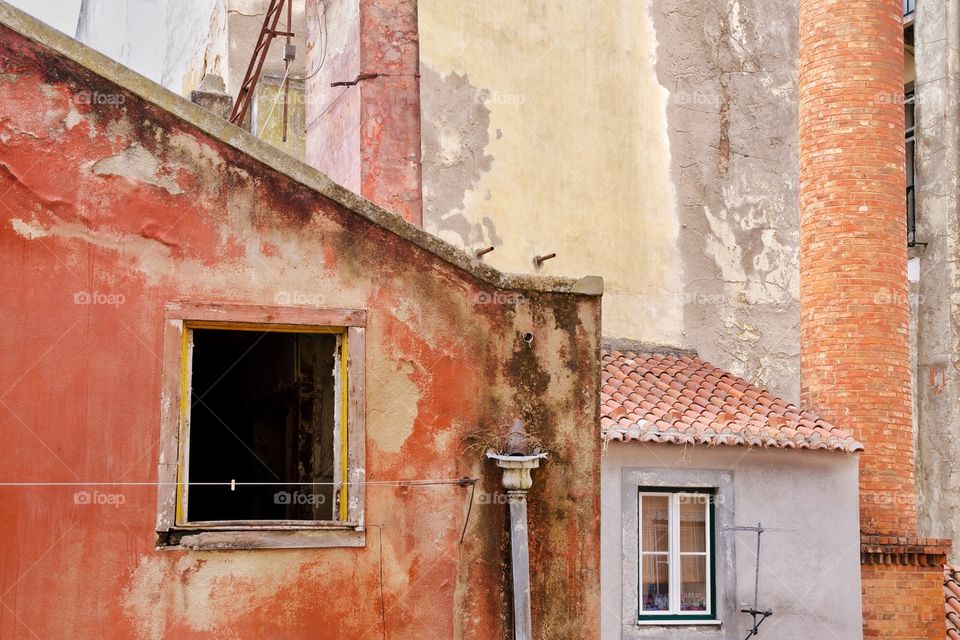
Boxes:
[157,305,364,549]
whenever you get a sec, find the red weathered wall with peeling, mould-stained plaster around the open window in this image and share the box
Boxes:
[0,22,599,639]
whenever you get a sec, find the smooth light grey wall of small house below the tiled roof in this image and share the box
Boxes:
[600,442,862,640]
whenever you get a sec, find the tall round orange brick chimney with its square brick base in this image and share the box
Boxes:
[799,0,947,638]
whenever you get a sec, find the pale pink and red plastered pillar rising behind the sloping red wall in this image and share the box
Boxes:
[306,0,423,226]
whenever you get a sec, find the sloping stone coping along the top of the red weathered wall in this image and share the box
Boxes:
[0,0,603,296]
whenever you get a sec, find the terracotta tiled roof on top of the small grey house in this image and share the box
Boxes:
[600,350,864,450]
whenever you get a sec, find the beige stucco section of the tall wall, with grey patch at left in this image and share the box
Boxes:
[419,0,682,344]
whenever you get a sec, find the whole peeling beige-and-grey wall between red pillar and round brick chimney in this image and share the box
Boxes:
[419,0,799,401]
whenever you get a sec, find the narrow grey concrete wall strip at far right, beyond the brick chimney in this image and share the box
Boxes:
[913,0,960,561]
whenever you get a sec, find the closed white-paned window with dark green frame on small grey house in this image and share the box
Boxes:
[637,487,717,624]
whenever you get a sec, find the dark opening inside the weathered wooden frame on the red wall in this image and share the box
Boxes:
[186,329,341,523]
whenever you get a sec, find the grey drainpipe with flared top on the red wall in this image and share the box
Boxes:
[487,450,547,640]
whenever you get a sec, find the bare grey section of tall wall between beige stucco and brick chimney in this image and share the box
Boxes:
[648,0,800,403]
